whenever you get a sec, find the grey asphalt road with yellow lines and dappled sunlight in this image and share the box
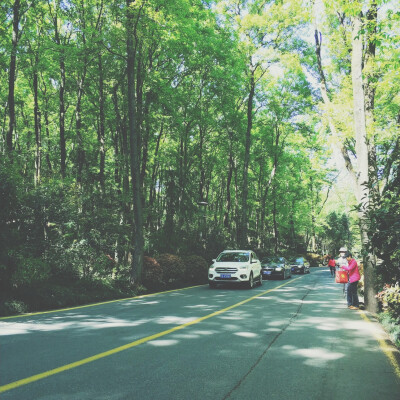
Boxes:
[0,268,400,400]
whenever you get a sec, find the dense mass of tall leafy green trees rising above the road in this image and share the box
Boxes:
[0,0,400,312]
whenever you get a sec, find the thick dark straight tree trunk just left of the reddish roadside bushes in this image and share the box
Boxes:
[127,0,144,284]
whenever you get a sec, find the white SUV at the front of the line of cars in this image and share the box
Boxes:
[208,250,262,289]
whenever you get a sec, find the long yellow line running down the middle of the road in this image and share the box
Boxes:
[0,277,302,393]
